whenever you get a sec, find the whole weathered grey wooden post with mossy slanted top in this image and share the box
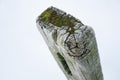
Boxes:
[36,7,103,80]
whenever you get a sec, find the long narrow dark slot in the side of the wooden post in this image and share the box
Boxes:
[57,53,72,75]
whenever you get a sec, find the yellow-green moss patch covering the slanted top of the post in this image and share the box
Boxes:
[37,7,82,27]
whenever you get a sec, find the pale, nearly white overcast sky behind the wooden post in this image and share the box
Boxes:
[0,0,120,80]
